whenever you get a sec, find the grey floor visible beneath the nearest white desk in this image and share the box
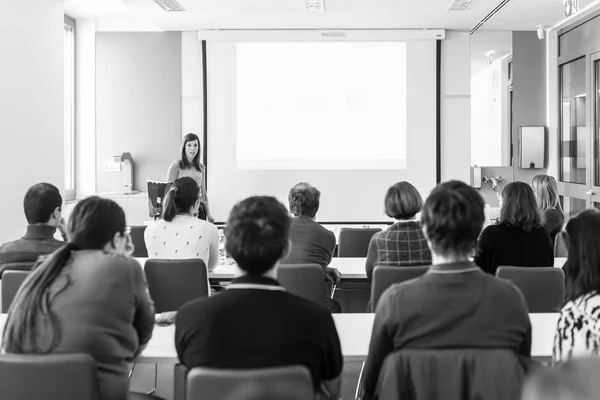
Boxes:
[131,362,362,400]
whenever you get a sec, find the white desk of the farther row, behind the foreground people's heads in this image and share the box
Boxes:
[136,257,567,281]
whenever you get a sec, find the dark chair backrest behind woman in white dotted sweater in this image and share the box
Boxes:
[144,258,208,313]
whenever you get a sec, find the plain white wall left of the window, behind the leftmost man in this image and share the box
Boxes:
[0,0,64,242]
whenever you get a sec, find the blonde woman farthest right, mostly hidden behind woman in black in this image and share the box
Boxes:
[531,175,565,243]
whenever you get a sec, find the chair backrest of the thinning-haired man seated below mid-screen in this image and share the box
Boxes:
[277,264,325,305]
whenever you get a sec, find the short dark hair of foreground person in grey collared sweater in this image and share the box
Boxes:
[421,181,485,256]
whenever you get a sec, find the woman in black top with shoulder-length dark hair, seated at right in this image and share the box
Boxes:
[475,182,554,275]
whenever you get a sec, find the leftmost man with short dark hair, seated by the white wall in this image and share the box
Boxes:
[0,183,64,273]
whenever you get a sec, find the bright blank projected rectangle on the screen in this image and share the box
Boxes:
[237,42,406,169]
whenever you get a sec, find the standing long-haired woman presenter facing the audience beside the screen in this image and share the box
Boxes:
[167,133,214,222]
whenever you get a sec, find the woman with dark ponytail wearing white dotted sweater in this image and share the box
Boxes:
[144,177,219,271]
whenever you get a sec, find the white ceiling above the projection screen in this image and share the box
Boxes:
[64,0,597,31]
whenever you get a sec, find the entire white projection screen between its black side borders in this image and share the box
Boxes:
[206,41,437,222]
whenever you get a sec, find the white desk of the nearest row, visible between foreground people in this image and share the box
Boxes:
[0,313,559,365]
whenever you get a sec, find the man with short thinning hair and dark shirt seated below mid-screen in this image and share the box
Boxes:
[281,182,342,312]
